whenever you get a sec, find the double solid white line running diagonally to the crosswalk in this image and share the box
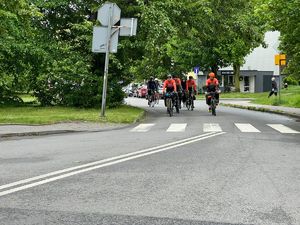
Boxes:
[0,132,225,197]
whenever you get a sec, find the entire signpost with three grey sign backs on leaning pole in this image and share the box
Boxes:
[92,2,137,117]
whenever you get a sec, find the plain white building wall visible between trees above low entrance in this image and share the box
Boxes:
[221,31,280,75]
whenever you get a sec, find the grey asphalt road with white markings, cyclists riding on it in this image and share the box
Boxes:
[0,98,300,225]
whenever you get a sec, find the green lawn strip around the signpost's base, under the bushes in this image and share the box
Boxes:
[0,105,144,124]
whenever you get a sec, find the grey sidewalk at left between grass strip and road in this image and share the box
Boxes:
[0,122,128,139]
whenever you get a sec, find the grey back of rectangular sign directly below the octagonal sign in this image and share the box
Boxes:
[92,27,119,53]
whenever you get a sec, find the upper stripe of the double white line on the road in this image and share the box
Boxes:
[0,133,213,190]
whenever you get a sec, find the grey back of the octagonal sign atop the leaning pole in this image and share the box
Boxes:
[97,2,121,26]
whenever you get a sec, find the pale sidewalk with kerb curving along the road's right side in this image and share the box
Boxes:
[220,99,300,118]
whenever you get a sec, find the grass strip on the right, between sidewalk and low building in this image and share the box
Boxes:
[197,86,300,108]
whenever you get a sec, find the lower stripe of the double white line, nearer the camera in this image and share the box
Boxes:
[0,132,225,197]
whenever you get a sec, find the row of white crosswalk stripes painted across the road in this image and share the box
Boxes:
[130,123,300,134]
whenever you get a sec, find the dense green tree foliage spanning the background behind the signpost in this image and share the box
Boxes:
[0,0,292,107]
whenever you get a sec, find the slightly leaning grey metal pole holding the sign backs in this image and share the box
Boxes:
[100,6,112,117]
